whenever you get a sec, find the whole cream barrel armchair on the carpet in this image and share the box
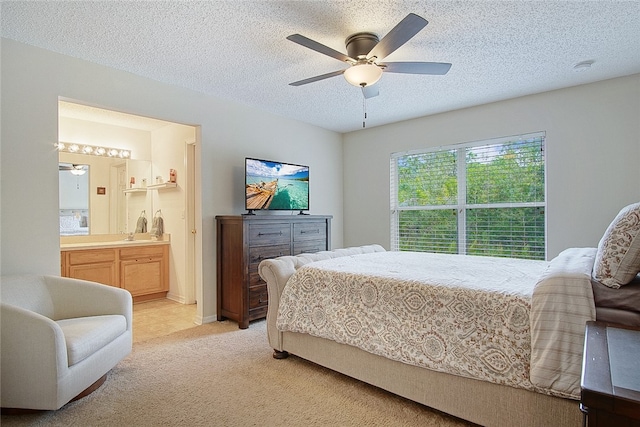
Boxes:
[0,276,132,410]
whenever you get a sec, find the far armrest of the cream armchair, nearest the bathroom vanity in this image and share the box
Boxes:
[44,276,133,330]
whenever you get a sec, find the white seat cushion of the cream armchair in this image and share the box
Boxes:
[56,314,127,366]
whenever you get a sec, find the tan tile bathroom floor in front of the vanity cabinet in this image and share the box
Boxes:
[133,299,197,343]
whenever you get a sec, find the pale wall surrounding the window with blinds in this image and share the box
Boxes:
[344,75,640,258]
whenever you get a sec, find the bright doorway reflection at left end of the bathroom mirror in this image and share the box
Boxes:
[58,163,90,236]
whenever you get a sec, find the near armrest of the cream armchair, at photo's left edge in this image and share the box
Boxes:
[0,303,68,388]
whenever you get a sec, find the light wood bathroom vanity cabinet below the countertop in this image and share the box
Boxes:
[61,244,169,303]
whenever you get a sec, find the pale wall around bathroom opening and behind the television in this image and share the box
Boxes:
[0,39,343,321]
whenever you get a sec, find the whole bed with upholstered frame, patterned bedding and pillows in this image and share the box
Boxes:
[259,203,640,426]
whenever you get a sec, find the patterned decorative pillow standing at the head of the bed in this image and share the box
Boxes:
[593,203,640,289]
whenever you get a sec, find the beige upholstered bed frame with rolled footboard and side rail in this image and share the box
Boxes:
[259,245,583,427]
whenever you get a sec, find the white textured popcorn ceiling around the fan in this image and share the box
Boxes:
[1,0,640,132]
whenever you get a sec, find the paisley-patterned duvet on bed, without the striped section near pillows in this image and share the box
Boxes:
[277,252,596,397]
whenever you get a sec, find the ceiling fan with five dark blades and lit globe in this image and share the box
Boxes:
[287,13,451,98]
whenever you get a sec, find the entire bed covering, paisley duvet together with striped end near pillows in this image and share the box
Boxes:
[277,249,595,398]
